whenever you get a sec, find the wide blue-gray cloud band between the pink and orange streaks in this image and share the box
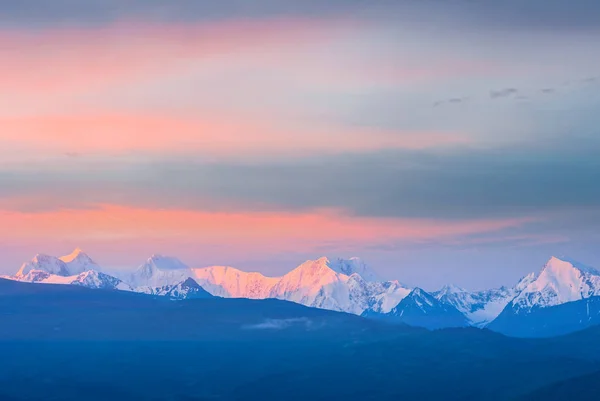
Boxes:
[0,138,600,219]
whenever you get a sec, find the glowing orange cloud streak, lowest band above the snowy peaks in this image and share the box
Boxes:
[0,205,531,251]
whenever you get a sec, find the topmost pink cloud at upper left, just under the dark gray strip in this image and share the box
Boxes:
[0,18,351,94]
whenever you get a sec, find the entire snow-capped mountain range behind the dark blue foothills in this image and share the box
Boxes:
[4,249,600,336]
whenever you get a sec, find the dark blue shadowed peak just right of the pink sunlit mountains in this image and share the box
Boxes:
[363,288,470,329]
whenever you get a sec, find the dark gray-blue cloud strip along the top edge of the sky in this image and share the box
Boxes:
[0,0,600,32]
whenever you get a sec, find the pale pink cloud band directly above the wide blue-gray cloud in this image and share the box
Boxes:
[0,114,467,162]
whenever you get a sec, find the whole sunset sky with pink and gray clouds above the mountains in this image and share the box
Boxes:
[0,0,600,290]
